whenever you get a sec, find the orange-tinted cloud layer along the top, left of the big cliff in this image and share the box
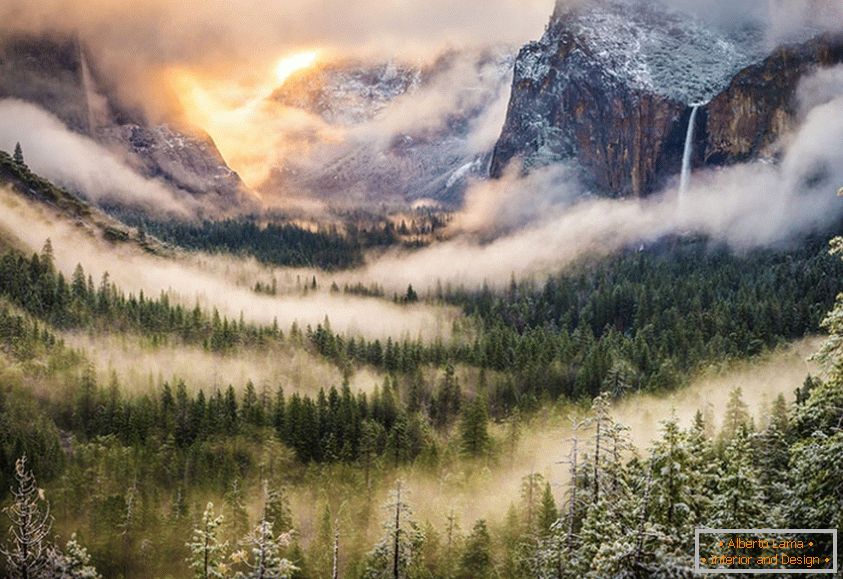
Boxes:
[0,0,553,125]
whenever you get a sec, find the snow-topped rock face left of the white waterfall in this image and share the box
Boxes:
[490,0,780,196]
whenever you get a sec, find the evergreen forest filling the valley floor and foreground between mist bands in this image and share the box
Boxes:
[0,230,843,578]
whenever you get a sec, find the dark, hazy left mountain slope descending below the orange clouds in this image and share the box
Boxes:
[0,36,249,206]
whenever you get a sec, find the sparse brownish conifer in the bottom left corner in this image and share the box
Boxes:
[2,455,53,579]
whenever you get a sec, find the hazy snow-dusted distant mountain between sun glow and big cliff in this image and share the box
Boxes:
[264,48,513,205]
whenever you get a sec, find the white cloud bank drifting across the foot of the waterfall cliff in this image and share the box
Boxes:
[332,65,843,291]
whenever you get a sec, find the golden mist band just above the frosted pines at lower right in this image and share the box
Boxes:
[362,337,822,530]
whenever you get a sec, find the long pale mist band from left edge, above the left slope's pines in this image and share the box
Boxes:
[0,185,456,339]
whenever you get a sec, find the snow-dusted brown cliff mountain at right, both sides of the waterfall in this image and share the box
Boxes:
[490,0,841,196]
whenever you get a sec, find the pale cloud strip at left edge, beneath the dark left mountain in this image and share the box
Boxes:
[0,99,198,216]
